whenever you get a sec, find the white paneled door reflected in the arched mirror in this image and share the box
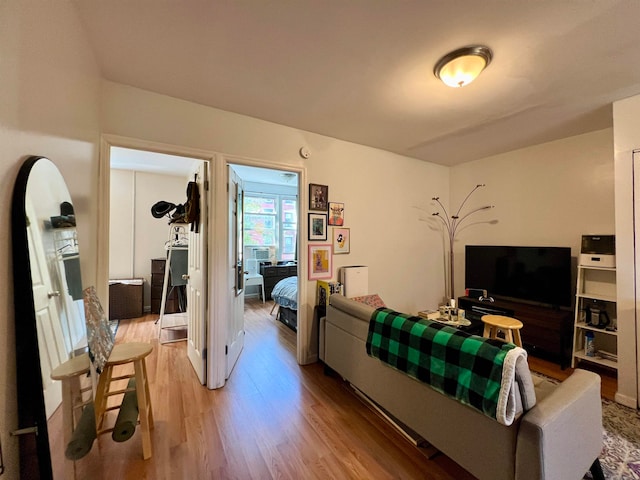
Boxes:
[26,196,68,418]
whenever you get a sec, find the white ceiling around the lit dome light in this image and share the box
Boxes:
[74,0,640,165]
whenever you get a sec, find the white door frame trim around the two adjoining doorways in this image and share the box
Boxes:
[96,134,310,389]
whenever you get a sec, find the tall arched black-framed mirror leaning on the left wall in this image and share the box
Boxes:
[12,157,91,479]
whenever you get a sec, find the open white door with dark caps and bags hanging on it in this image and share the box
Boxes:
[187,162,209,384]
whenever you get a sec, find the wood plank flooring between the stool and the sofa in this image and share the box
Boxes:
[54,299,616,480]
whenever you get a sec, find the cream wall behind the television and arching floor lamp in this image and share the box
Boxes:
[451,129,615,292]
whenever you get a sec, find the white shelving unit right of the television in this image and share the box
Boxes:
[571,265,618,370]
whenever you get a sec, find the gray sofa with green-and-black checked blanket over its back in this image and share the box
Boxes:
[320,295,604,480]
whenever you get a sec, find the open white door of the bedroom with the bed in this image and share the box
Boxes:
[225,166,244,378]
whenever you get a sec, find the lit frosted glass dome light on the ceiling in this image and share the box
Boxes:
[433,45,493,87]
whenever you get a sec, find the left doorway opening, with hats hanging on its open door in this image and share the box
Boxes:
[103,142,209,383]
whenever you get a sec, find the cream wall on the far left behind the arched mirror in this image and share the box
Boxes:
[0,1,100,480]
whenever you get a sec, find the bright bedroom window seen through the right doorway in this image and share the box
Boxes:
[244,193,298,260]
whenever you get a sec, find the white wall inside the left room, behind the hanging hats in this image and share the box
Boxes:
[109,169,189,307]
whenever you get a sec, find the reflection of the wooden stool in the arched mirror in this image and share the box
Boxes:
[51,353,91,478]
